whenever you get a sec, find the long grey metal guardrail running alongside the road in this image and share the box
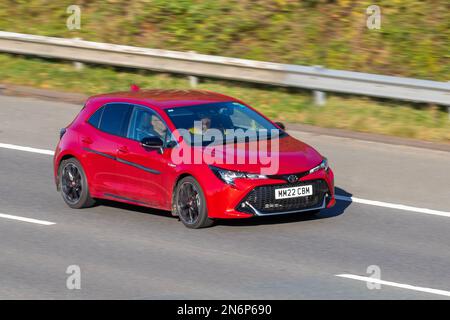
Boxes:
[0,31,450,106]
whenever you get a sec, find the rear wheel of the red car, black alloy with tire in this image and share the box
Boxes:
[58,158,95,209]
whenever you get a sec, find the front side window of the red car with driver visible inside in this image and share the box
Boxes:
[127,106,170,141]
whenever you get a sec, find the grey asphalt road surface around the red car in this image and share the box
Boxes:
[0,97,450,299]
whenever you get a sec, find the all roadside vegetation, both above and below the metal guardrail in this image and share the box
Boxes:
[0,0,450,142]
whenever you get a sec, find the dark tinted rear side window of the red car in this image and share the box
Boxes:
[99,103,133,137]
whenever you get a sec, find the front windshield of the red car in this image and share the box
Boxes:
[166,102,287,146]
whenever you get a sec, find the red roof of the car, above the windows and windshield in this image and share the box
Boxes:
[89,89,238,109]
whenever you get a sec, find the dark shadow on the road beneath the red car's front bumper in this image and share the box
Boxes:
[216,187,352,227]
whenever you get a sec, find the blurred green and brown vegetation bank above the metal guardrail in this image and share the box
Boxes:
[0,0,450,81]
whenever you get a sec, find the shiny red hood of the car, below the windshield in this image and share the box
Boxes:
[194,135,323,174]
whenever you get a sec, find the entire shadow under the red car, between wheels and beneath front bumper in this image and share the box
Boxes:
[96,187,352,227]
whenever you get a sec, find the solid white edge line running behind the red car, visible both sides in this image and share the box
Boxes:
[0,143,450,218]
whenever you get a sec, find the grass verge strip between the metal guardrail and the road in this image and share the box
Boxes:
[0,54,450,142]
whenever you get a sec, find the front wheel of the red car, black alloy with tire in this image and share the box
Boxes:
[172,176,214,229]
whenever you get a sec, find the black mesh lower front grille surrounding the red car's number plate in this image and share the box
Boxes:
[236,179,328,214]
